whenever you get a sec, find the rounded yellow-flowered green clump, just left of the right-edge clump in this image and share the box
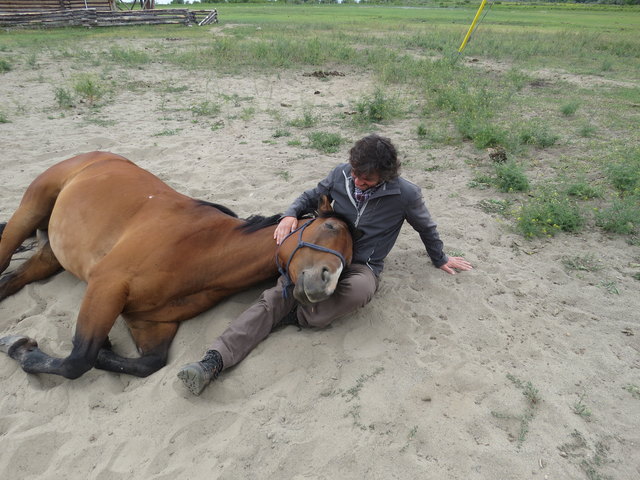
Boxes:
[516,191,585,238]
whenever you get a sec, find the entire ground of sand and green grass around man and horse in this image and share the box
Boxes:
[0,2,640,480]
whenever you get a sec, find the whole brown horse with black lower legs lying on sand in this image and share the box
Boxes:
[0,152,352,378]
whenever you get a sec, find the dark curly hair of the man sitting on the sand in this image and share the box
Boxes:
[349,134,400,182]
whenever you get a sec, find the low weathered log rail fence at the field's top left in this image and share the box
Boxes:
[0,8,218,28]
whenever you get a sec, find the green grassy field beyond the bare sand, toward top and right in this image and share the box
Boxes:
[0,4,640,238]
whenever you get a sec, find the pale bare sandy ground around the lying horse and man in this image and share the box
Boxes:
[0,34,640,480]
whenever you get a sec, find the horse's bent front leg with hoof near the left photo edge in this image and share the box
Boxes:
[0,284,126,379]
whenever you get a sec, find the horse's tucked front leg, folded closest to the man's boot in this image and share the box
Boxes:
[95,322,179,377]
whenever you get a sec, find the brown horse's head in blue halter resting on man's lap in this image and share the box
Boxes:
[277,196,353,305]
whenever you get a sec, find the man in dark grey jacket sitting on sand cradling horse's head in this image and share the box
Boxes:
[178,135,472,395]
